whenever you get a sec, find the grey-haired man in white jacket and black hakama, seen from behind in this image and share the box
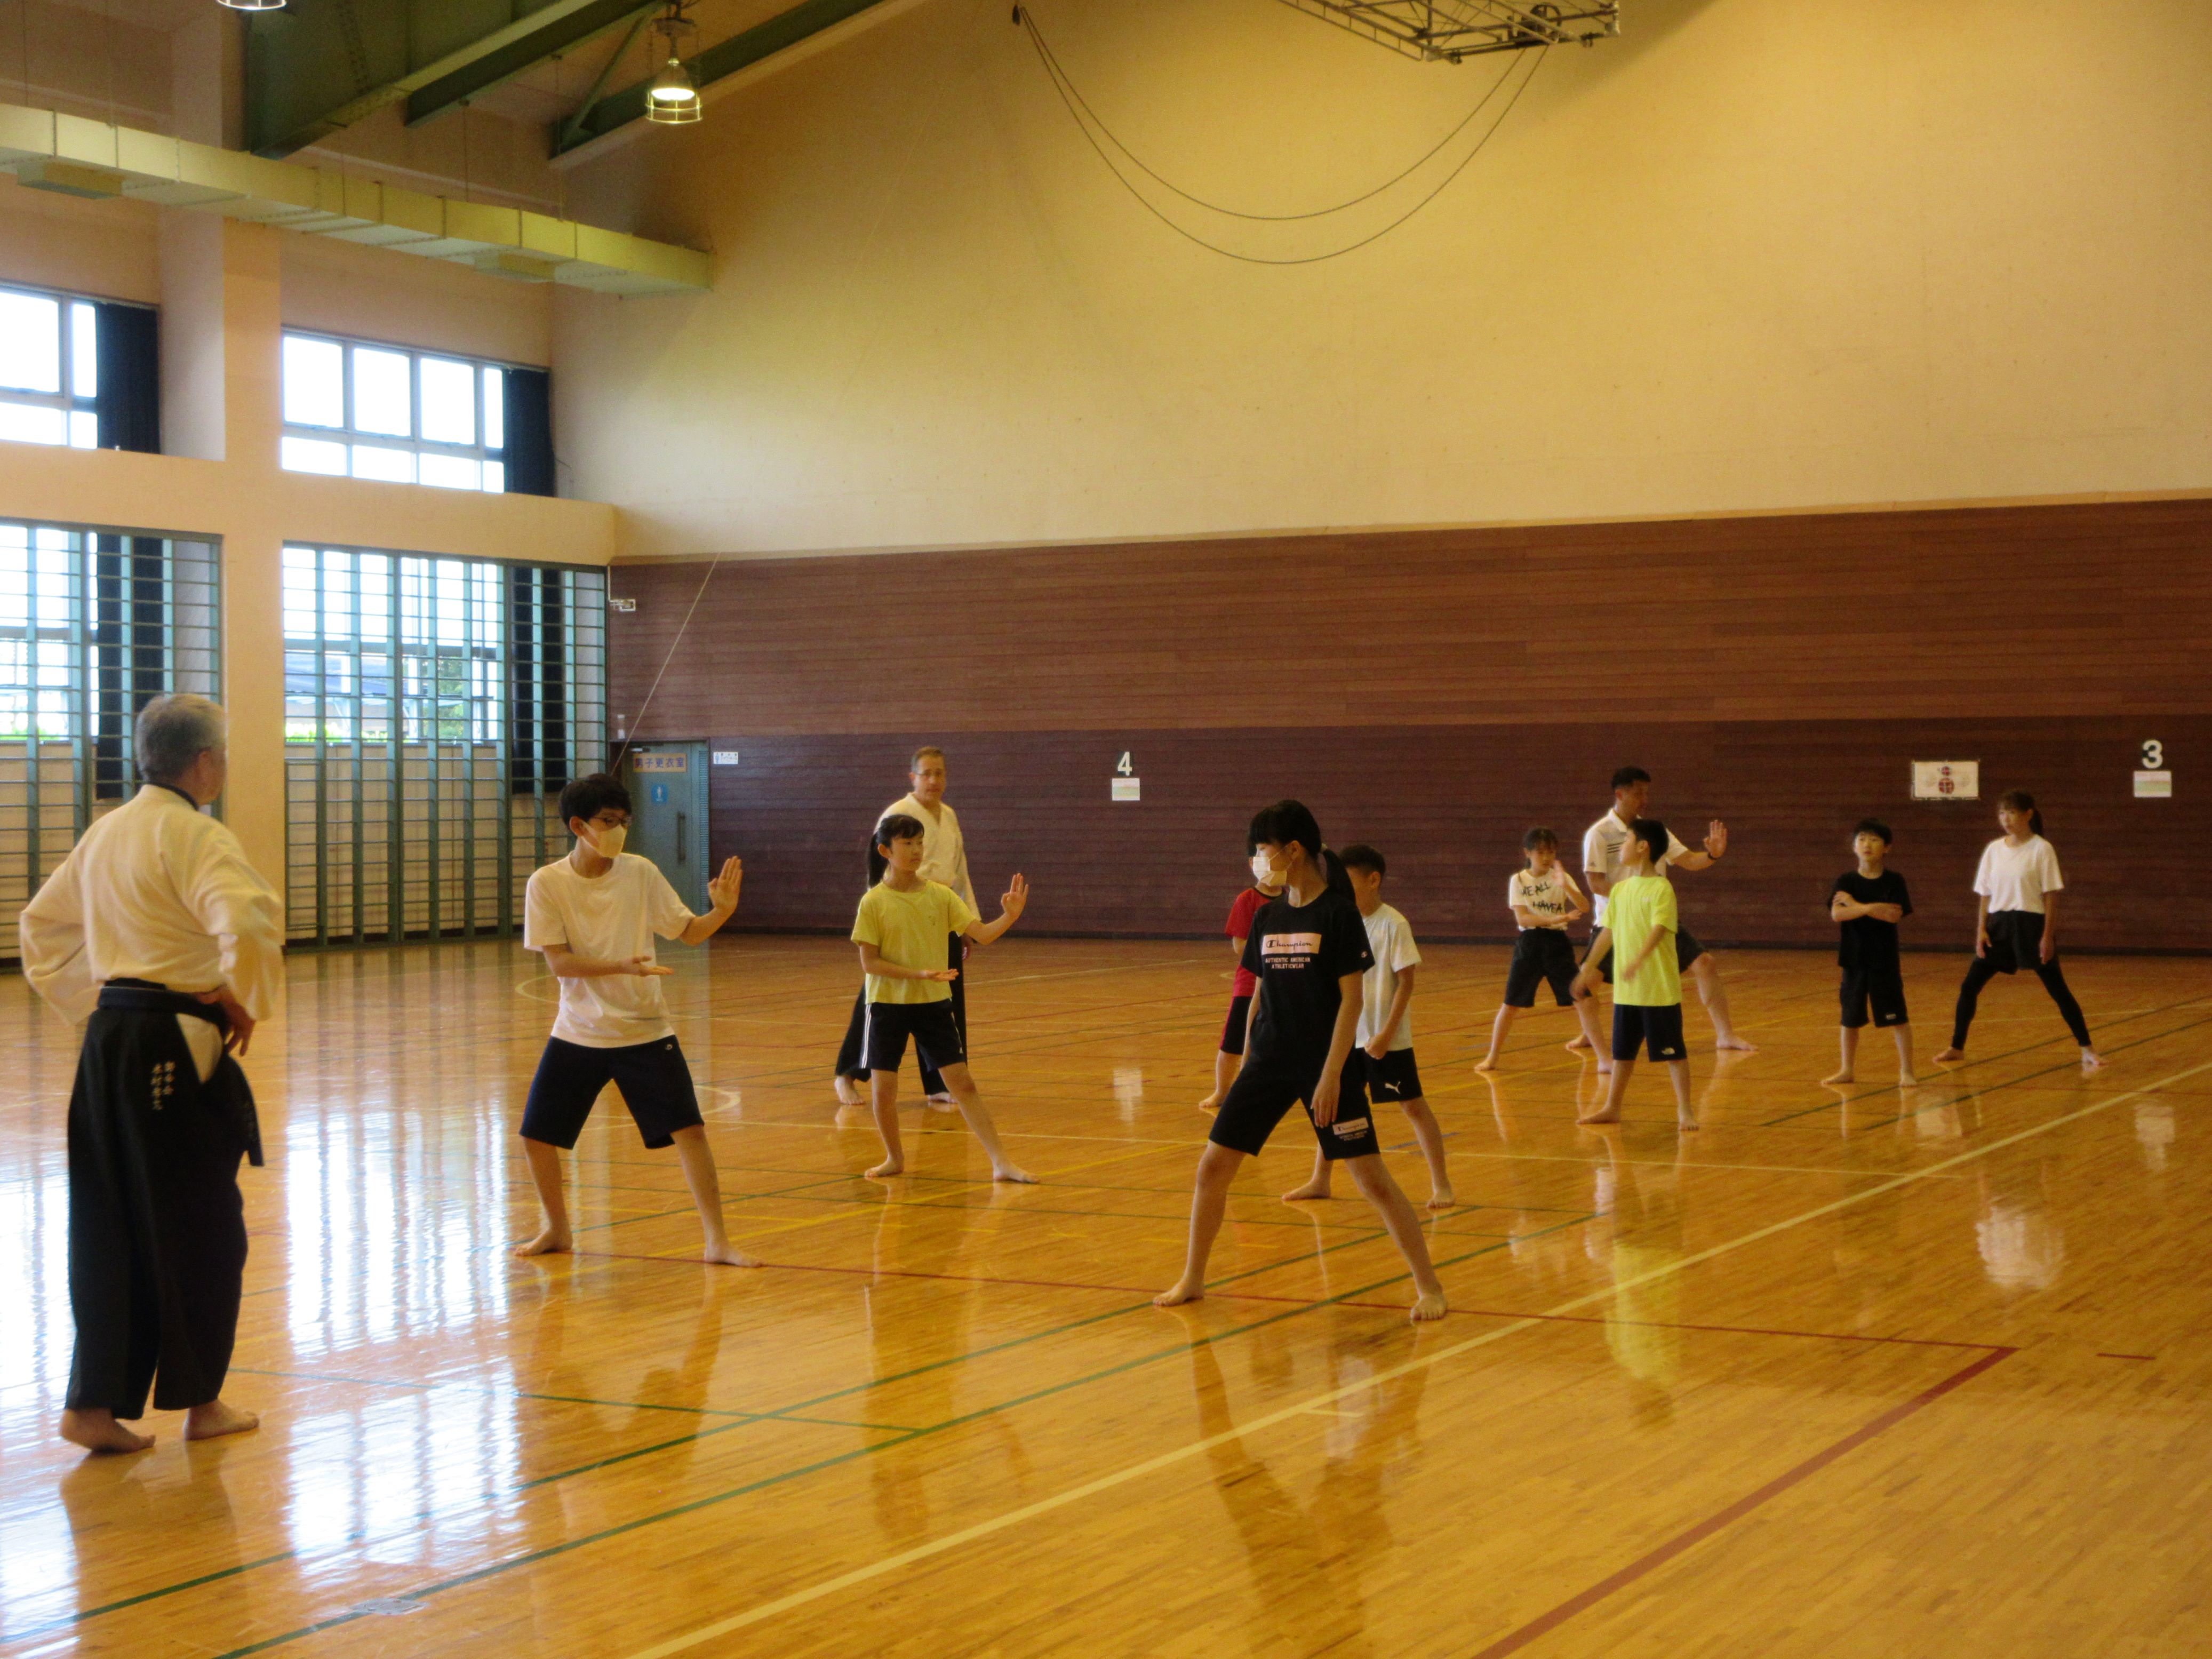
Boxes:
[20,695,283,1451]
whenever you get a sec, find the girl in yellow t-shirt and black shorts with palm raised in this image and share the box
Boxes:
[852,812,1037,1181]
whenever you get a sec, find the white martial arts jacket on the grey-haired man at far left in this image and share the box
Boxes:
[18,783,283,1035]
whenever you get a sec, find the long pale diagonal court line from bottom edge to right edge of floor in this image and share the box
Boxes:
[628,1059,2212,1659]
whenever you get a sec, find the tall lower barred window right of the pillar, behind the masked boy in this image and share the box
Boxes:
[283,546,606,945]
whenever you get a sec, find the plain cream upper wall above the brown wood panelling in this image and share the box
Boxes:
[555,0,2212,555]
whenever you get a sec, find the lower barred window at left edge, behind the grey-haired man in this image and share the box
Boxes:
[0,520,219,958]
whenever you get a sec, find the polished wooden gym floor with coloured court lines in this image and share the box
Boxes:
[0,938,2212,1659]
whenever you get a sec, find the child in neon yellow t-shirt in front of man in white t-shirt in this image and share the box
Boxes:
[1575,818,1697,1128]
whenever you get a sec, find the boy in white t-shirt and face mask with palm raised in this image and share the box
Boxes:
[515,772,761,1267]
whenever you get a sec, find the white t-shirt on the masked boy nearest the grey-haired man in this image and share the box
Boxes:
[522,851,692,1049]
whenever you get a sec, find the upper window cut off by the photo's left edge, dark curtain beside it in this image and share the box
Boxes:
[0,288,162,449]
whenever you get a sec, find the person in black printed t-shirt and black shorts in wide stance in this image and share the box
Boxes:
[1153,801,1447,1318]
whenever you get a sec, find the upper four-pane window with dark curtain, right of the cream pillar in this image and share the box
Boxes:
[279,332,548,496]
